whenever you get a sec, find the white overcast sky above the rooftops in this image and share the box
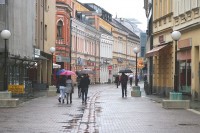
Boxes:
[78,0,147,31]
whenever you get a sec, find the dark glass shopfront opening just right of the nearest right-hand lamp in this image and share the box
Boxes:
[179,60,191,94]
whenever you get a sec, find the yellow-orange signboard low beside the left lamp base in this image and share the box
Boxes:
[8,85,25,94]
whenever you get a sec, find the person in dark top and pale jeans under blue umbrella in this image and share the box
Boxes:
[58,75,66,103]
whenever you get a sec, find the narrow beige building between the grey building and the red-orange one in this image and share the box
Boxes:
[34,0,56,88]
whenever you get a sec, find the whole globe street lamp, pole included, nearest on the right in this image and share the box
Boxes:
[171,31,181,92]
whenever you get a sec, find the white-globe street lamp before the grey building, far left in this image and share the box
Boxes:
[1,30,11,90]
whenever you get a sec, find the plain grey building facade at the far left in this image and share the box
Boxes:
[0,0,35,90]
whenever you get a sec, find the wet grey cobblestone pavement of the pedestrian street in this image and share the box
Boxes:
[0,84,200,133]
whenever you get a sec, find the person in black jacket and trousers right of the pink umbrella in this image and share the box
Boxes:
[80,74,90,104]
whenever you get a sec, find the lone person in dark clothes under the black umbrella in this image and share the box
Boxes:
[120,73,128,97]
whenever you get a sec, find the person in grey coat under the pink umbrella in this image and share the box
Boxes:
[66,76,74,104]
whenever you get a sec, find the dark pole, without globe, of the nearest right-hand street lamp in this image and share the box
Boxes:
[174,41,178,92]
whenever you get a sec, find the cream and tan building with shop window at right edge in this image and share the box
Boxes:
[173,0,200,100]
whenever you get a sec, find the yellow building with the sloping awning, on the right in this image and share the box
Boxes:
[146,0,174,95]
